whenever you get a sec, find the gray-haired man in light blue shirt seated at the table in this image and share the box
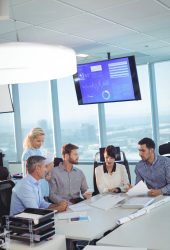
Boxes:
[10,156,67,215]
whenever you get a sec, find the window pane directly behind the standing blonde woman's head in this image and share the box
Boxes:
[19,82,54,152]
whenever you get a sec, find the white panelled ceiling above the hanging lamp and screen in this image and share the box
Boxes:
[0,0,170,64]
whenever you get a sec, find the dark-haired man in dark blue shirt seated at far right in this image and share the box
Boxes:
[135,137,170,196]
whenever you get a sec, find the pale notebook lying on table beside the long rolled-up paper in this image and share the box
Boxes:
[122,197,155,208]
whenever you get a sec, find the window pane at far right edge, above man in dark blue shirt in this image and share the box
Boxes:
[155,61,170,144]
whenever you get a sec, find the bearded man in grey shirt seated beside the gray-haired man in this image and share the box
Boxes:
[49,143,92,204]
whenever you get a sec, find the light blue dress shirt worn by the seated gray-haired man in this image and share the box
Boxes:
[10,174,51,215]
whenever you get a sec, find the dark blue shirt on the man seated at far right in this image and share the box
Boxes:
[135,155,170,194]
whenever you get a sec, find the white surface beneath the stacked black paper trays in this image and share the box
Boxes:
[7,235,66,250]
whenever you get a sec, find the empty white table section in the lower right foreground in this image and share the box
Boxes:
[97,199,170,250]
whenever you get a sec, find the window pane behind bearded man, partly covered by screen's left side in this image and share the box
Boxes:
[57,77,99,160]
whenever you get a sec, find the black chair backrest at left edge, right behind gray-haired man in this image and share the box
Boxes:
[0,180,15,218]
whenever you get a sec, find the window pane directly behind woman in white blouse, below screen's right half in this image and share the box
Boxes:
[105,65,152,160]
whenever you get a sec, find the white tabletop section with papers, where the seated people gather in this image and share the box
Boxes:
[55,195,137,241]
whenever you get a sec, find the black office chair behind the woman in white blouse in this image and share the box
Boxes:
[93,147,131,195]
